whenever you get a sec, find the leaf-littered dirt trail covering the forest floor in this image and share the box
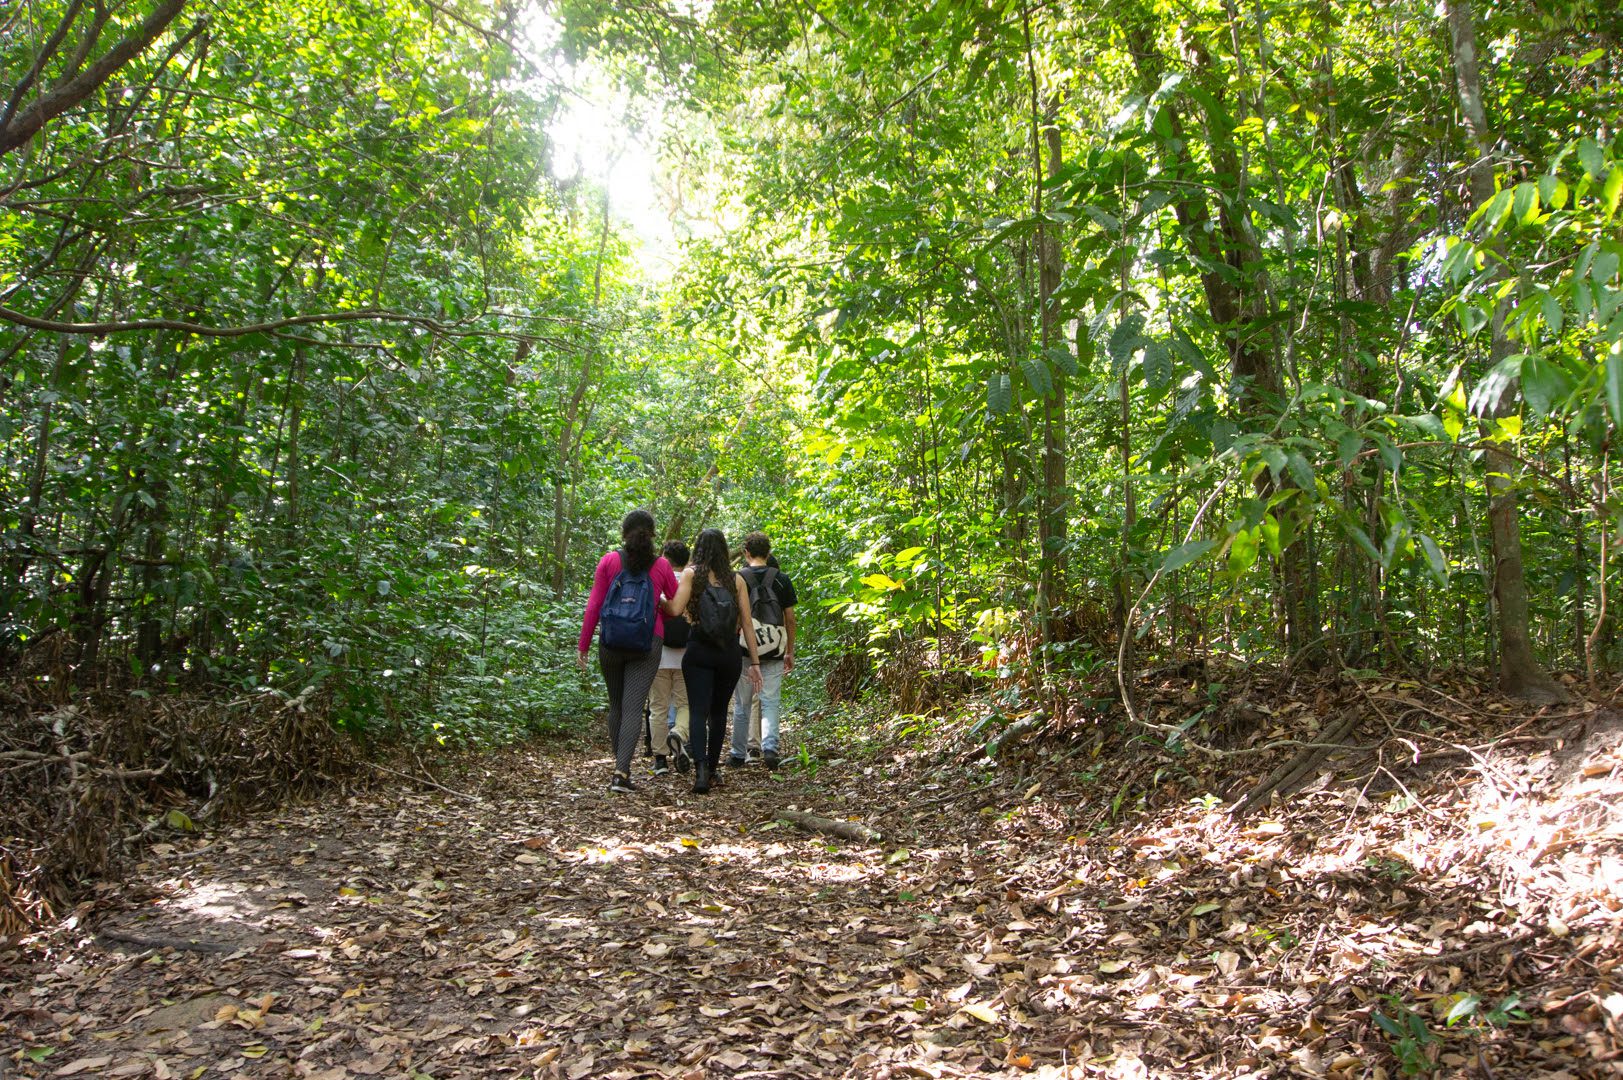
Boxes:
[9,704,1623,1080]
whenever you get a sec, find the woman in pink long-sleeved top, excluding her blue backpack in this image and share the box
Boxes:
[579,510,680,791]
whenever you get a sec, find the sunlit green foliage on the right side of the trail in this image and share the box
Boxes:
[551,3,1623,682]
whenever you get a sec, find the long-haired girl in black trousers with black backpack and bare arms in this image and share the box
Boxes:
[658,529,761,794]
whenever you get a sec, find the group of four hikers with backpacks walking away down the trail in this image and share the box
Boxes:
[578,510,795,794]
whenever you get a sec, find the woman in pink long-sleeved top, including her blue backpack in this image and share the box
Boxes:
[578,510,682,793]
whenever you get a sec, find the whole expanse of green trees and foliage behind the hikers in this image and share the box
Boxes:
[0,0,1623,741]
